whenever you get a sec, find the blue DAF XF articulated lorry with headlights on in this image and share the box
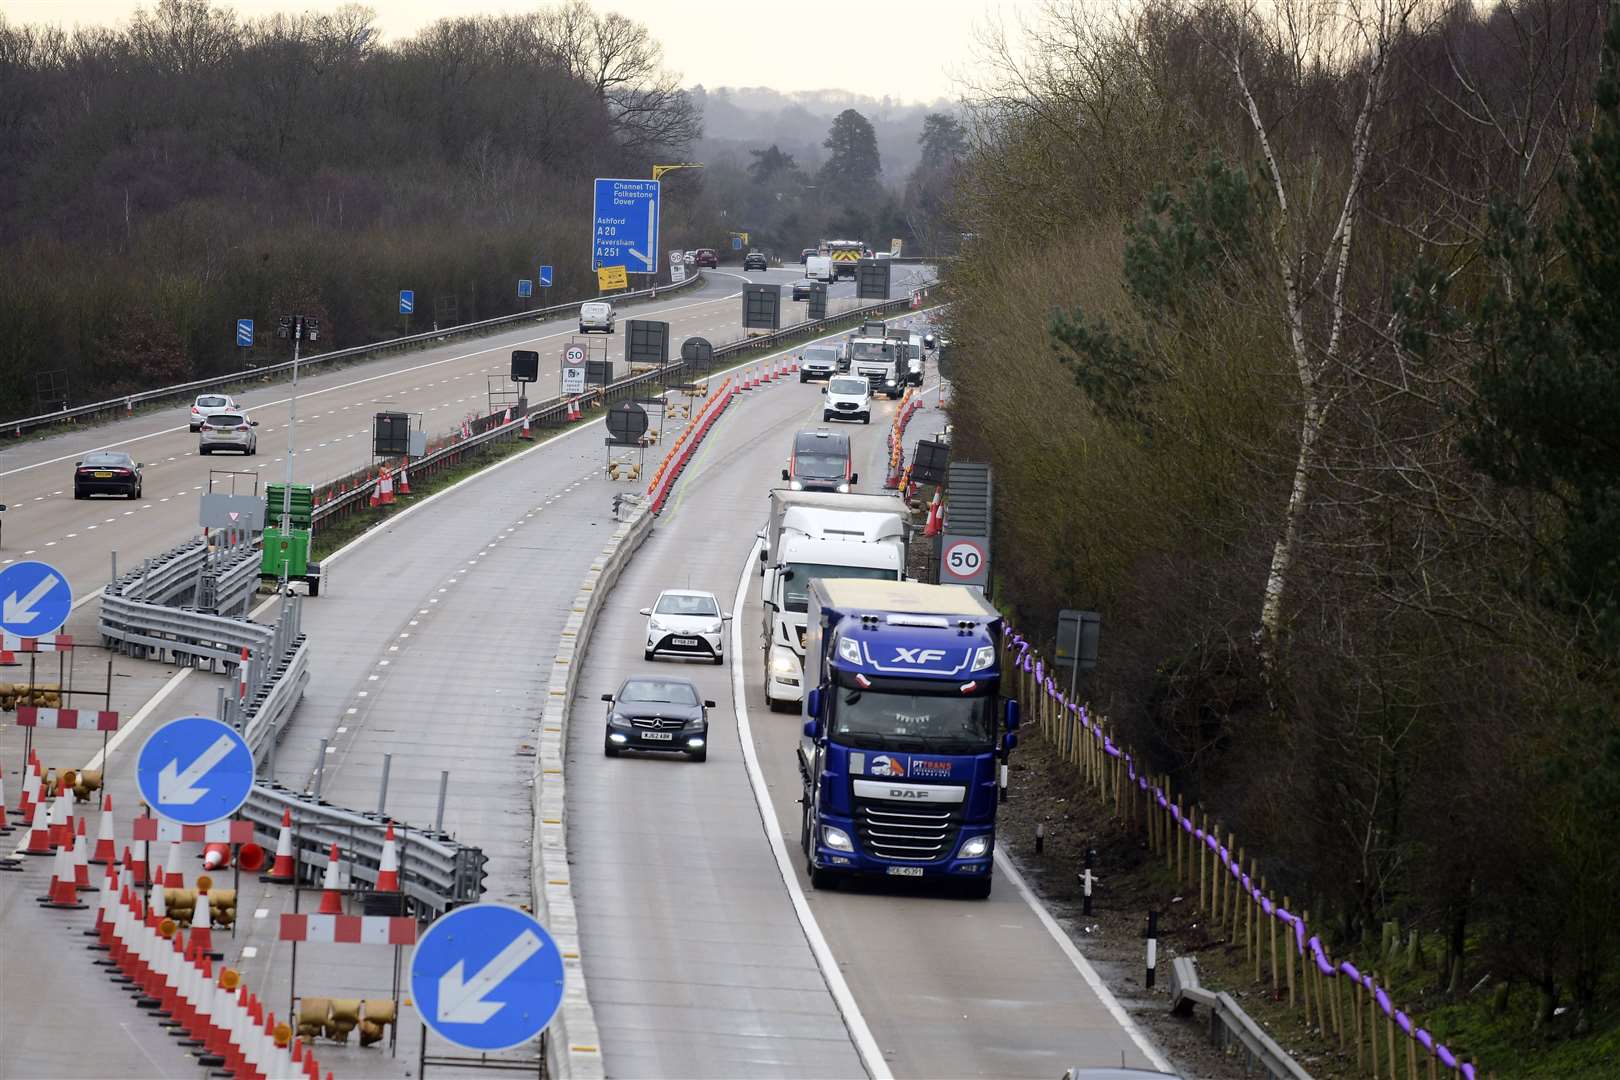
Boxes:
[799,578,1019,897]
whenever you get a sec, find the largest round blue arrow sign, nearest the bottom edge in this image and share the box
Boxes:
[410,904,564,1051]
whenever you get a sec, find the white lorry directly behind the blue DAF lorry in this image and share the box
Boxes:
[760,489,906,709]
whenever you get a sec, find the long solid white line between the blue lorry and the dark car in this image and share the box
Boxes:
[731,541,894,1080]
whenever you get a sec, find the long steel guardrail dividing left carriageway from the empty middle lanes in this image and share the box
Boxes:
[311,279,936,526]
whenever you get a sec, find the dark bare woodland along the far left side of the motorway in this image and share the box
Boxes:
[0,0,700,416]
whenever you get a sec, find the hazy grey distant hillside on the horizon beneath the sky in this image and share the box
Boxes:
[690,86,956,188]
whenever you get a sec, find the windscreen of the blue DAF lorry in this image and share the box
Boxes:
[833,672,995,755]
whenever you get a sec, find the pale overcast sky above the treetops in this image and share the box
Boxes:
[0,0,1040,102]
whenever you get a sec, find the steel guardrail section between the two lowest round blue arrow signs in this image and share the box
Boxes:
[241,784,489,915]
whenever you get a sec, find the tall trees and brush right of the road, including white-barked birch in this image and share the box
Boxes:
[948,0,1620,1077]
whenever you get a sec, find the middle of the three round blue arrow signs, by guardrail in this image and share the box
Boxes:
[134,716,253,826]
